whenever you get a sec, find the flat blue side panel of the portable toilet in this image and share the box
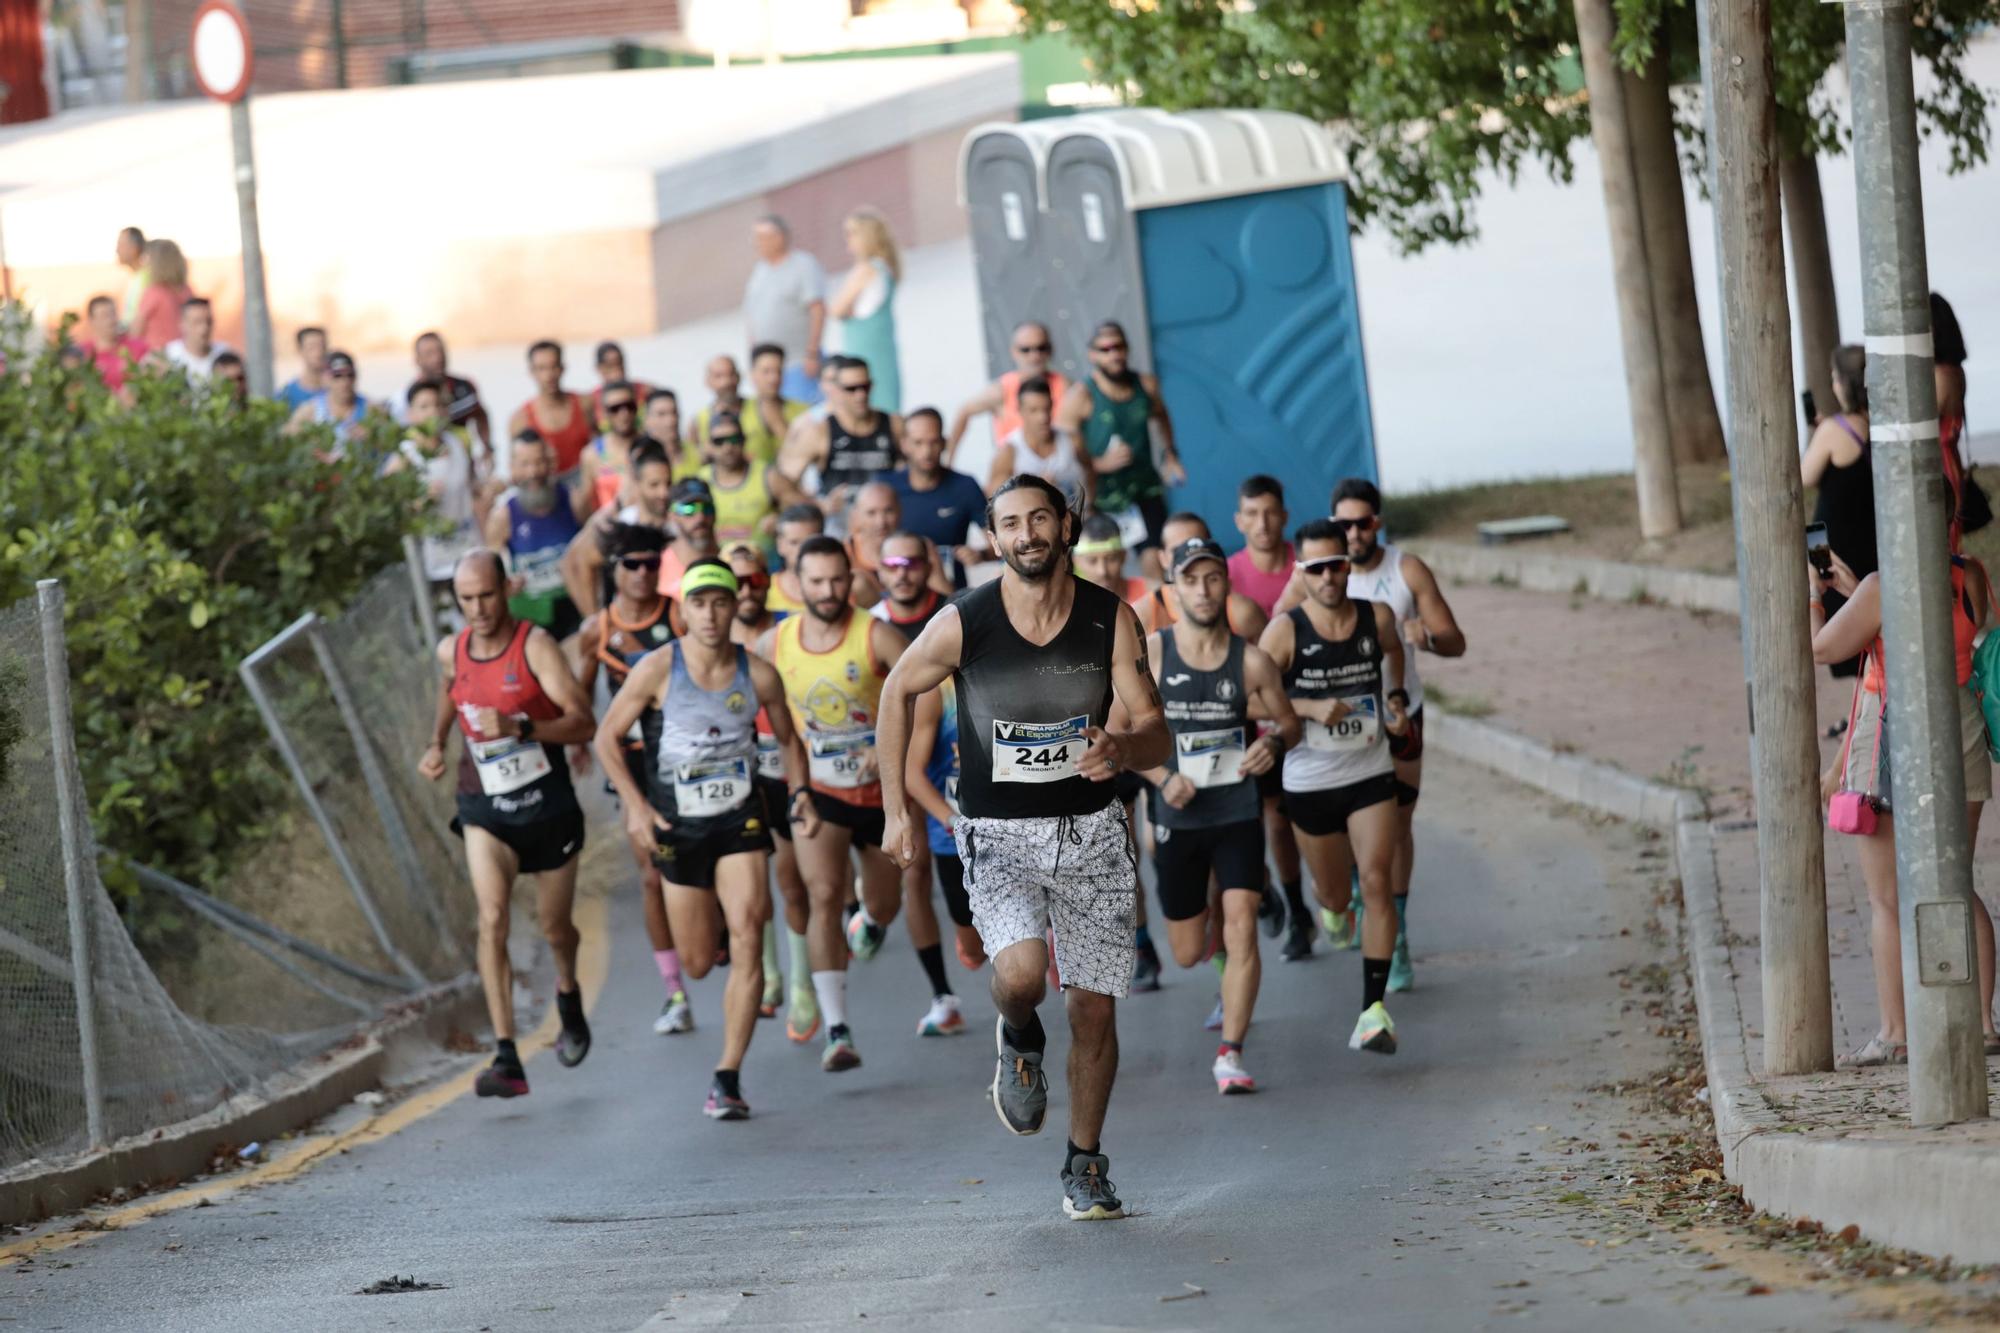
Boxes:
[1138,184,1376,546]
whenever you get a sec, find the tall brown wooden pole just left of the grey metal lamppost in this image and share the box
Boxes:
[1702,0,1834,1075]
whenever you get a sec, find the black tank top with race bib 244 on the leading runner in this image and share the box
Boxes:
[954,572,1124,819]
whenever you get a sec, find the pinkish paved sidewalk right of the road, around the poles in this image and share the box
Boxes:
[1422,580,2000,1261]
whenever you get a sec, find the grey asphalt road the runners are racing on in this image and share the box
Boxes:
[0,763,1936,1333]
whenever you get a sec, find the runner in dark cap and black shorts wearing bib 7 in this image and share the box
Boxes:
[1144,536,1300,1093]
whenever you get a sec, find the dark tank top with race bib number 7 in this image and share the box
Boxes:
[1152,628,1262,829]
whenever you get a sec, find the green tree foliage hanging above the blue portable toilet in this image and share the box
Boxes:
[1022,0,1590,252]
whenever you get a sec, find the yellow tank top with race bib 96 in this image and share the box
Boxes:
[772,610,888,807]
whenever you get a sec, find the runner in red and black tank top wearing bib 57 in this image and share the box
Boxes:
[416,550,596,1097]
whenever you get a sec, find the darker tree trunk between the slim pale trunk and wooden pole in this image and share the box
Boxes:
[1622,44,1728,462]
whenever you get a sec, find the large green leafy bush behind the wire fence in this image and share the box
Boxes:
[0,312,422,935]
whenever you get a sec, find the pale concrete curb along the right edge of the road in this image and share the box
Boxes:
[1424,713,2000,1263]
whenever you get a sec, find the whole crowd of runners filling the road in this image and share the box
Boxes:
[180,223,1466,1219]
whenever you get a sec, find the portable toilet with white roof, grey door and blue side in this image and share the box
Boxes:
[962,110,1378,544]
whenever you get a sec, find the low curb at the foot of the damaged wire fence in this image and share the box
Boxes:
[0,975,486,1225]
